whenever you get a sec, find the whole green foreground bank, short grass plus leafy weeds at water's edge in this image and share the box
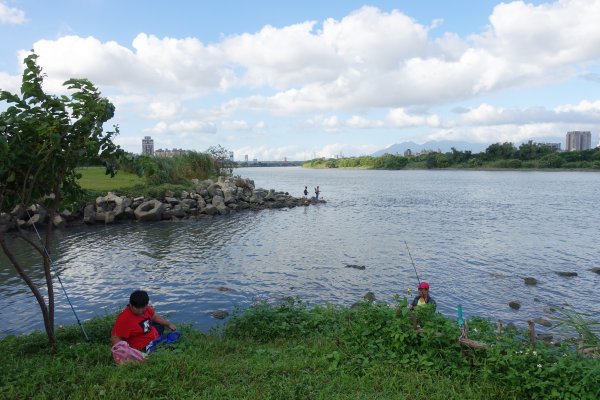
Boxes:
[0,302,600,399]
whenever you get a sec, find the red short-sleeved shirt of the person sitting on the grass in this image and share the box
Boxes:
[112,306,159,350]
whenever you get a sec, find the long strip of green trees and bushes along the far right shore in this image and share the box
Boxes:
[303,141,600,170]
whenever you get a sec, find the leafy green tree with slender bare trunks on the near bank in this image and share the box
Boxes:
[0,53,122,347]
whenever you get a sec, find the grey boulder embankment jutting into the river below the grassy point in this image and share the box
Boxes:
[0,177,325,232]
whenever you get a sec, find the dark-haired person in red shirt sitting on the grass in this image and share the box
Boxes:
[110,290,176,351]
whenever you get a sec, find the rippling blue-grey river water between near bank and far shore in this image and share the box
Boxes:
[0,168,600,337]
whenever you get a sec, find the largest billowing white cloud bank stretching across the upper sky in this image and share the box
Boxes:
[10,0,600,115]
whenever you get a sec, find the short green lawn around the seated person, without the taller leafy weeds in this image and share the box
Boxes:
[0,317,510,399]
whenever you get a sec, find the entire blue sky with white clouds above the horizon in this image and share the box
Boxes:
[0,0,600,161]
